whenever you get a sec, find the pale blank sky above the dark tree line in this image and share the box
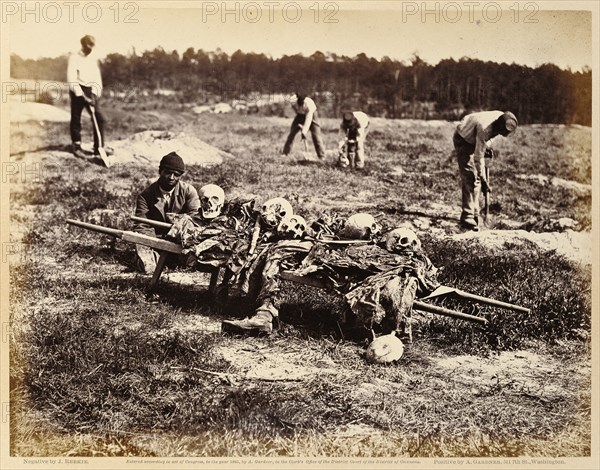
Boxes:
[2,0,597,70]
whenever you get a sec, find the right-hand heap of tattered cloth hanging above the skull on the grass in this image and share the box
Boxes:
[295,243,439,328]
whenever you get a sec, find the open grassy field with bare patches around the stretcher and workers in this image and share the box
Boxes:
[5,96,592,458]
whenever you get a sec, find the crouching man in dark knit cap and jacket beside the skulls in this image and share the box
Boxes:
[134,152,200,274]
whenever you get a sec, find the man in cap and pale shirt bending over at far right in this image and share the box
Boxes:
[453,111,518,231]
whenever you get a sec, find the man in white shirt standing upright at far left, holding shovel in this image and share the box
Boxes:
[67,35,105,158]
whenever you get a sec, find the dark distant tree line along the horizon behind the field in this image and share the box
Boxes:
[11,47,592,126]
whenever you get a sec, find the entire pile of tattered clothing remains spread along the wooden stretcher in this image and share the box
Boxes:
[168,200,439,326]
